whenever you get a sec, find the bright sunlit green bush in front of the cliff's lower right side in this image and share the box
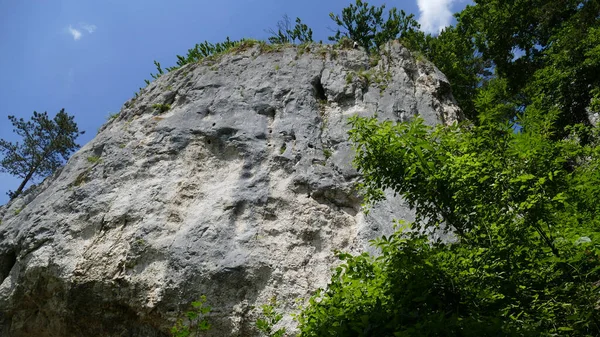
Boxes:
[299,109,600,337]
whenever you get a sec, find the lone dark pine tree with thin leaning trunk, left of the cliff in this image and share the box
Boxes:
[0,109,84,199]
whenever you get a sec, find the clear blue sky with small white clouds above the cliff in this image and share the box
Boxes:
[0,0,467,204]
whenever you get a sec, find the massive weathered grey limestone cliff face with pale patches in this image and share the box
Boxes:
[0,42,459,337]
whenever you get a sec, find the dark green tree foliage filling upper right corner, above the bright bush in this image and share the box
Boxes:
[404,0,600,130]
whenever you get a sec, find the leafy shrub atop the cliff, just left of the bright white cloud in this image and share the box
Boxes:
[329,0,419,51]
